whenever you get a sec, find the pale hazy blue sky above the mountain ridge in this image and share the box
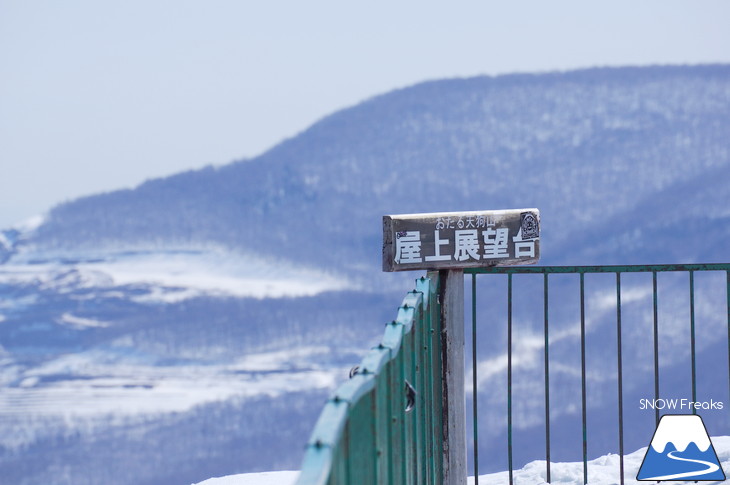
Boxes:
[0,0,730,228]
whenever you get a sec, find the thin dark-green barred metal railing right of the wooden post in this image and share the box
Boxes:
[465,264,730,484]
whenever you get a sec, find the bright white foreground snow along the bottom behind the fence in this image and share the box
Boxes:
[197,436,730,485]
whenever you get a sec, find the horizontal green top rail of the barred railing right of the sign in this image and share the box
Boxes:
[464,263,730,274]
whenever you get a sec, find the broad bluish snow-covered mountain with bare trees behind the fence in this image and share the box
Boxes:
[0,66,730,484]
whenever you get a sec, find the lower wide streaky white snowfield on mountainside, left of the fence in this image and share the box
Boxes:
[0,347,347,448]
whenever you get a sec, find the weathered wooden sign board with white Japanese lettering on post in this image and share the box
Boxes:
[383,209,540,271]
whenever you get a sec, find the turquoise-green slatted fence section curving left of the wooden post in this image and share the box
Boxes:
[296,273,443,485]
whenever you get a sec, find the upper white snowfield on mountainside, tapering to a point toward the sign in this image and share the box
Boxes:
[0,249,354,303]
